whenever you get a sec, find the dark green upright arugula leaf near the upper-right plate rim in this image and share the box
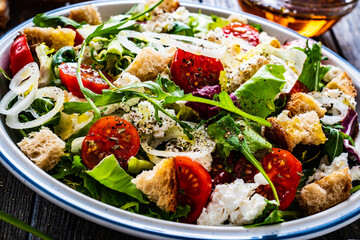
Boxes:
[296,41,331,91]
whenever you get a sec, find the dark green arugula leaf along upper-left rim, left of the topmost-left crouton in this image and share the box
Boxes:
[33,13,83,28]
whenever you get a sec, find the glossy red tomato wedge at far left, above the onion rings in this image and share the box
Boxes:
[10,35,34,76]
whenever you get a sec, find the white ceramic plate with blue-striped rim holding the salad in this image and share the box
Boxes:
[0,1,360,239]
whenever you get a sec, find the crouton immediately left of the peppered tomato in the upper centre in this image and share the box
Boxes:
[126,47,172,81]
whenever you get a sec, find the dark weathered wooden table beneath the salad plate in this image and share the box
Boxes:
[0,0,360,240]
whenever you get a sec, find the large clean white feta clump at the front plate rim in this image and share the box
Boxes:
[197,179,267,226]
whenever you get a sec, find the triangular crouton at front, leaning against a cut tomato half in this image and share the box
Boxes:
[132,158,178,212]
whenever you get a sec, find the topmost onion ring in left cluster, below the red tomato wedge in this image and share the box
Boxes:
[9,62,40,95]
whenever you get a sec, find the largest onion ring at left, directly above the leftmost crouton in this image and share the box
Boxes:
[6,87,65,129]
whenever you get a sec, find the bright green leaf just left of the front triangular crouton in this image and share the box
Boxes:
[86,155,148,203]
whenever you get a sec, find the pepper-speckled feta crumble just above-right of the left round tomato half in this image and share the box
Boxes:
[123,101,176,138]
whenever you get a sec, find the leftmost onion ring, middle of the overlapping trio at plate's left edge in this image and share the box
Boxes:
[0,83,38,115]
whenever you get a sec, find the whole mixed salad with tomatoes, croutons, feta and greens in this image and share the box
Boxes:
[0,0,360,227]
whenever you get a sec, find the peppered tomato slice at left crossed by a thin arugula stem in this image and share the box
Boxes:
[59,63,112,97]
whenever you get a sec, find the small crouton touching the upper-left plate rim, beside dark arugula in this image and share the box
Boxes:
[69,4,102,25]
